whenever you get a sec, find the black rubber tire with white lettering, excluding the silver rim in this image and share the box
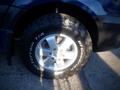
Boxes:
[22,13,92,78]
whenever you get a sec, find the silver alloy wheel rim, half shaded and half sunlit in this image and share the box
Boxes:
[35,34,78,72]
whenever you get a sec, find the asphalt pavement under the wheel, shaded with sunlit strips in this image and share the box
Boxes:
[0,49,120,90]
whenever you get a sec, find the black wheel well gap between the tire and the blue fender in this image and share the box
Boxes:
[13,3,98,50]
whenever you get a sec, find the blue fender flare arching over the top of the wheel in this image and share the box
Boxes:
[4,0,106,27]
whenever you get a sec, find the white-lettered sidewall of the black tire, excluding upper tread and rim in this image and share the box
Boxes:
[24,13,90,78]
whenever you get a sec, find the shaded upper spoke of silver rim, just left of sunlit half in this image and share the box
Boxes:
[46,36,57,50]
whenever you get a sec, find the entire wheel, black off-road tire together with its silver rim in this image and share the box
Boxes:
[23,13,92,78]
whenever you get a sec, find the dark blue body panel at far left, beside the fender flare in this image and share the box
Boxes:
[0,0,14,53]
